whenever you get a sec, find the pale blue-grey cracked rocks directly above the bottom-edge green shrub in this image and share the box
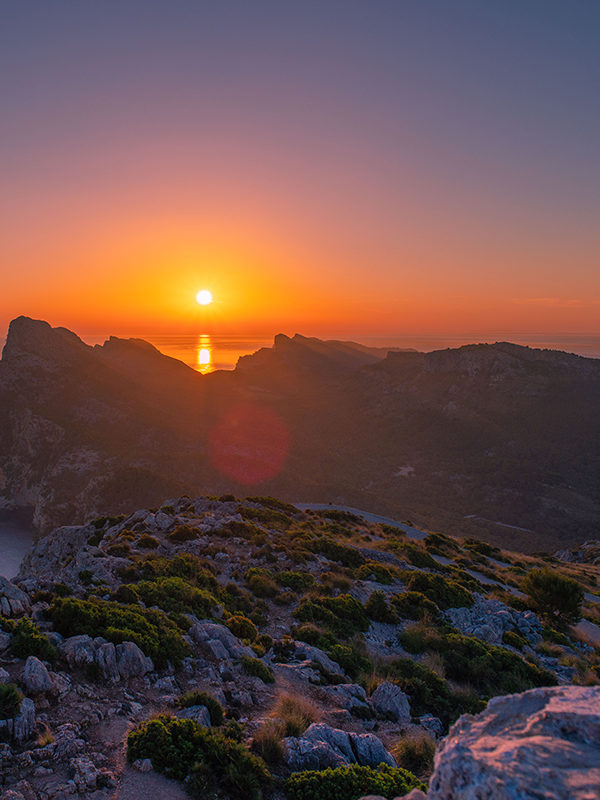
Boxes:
[284,722,396,771]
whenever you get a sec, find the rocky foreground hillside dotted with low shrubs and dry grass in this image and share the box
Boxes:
[0,496,600,800]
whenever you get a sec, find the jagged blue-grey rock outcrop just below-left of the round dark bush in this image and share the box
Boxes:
[444,595,542,646]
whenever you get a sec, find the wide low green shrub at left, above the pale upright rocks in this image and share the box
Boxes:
[48,597,189,667]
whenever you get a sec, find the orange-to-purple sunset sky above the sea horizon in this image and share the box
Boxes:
[0,0,600,336]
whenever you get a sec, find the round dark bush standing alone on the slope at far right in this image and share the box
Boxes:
[523,567,585,628]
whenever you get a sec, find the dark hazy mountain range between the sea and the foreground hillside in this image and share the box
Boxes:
[0,317,600,552]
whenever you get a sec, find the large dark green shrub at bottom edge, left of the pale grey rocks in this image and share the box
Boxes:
[127,715,271,800]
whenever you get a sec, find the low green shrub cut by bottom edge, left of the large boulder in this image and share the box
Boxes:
[285,764,426,800]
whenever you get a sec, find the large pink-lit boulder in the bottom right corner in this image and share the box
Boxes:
[427,686,600,800]
